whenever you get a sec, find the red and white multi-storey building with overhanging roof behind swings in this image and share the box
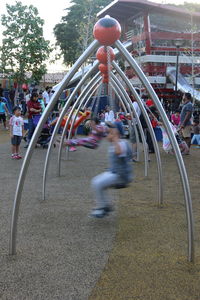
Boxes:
[98,0,200,102]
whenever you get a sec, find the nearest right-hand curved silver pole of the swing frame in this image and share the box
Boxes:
[115,41,194,262]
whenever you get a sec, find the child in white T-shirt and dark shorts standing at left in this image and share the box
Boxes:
[9,106,24,159]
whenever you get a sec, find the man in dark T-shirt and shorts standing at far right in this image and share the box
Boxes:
[180,93,193,154]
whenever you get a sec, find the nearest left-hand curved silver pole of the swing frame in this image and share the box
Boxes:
[9,40,99,255]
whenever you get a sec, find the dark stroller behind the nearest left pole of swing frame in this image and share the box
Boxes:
[33,115,51,149]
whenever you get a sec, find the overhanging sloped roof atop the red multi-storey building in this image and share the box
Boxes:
[97,0,200,21]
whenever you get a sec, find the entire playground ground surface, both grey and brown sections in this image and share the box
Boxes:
[0,127,200,300]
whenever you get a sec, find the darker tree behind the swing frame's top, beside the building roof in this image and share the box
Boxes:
[54,0,112,65]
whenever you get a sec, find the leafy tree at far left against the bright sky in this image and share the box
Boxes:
[0,2,51,84]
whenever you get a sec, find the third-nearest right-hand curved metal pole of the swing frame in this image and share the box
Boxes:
[112,73,148,176]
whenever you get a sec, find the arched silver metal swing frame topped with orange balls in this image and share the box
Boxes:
[9,16,194,261]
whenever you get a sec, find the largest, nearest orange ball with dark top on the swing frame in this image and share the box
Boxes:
[93,16,121,46]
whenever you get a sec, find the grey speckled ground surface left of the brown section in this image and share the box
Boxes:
[0,132,117,300]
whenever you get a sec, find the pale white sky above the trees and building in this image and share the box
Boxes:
[0,0,200,71]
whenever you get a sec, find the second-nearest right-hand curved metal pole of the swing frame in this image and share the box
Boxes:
[112,61,163,206]
